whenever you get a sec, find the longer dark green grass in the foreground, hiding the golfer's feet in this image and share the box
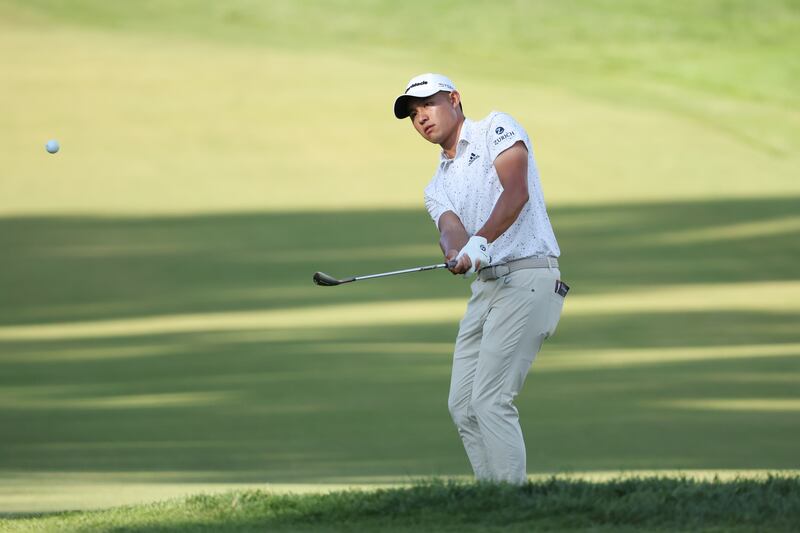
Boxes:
[0,477,800,532]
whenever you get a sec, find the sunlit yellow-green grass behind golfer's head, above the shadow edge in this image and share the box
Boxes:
[0,0,800,215]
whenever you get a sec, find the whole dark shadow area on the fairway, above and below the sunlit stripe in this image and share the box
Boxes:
[0,198,800,482]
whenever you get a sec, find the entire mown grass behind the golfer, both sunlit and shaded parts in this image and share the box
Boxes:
[0,0,800,527]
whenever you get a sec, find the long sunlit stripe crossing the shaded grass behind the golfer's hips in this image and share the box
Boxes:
[0,281,800,341]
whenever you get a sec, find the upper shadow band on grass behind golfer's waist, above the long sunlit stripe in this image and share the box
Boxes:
[0,194,800,324]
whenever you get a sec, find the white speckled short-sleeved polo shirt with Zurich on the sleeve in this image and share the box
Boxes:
[425,111,561,265]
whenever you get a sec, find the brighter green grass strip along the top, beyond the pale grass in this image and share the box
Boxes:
[3,0,800,104]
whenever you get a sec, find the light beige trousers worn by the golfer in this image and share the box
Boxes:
[448,268,564,484]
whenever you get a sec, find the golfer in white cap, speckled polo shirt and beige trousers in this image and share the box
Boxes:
[394,74,569,484]
